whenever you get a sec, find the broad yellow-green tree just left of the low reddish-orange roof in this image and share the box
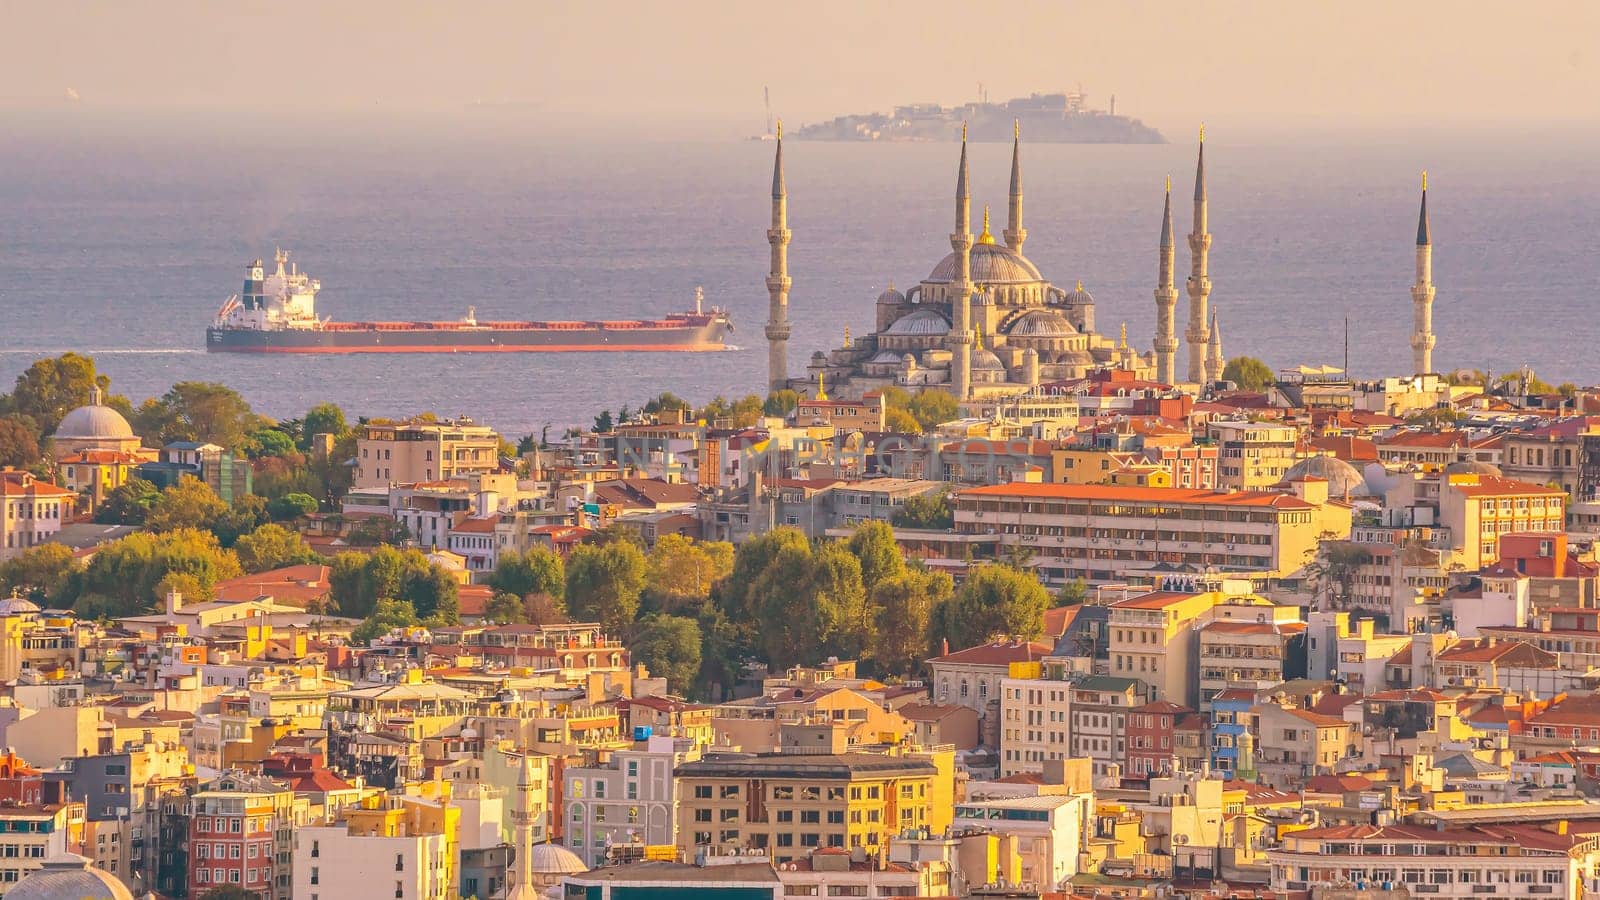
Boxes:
[75,528,243,617]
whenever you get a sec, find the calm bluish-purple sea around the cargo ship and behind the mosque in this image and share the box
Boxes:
[0,114,1600,436]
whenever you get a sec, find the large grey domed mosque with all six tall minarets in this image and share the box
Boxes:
[766,128,1434,400]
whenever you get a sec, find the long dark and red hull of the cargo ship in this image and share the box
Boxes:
[206,317,730,354]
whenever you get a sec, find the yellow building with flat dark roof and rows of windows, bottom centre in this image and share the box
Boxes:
[677,751,955,863]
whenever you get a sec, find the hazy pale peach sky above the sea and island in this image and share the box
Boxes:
[0,0,1600,131]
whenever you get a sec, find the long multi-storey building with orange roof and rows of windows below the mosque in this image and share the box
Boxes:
[898,480,1350,585]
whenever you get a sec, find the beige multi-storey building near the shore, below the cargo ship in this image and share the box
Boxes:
[354,418,499,490]
